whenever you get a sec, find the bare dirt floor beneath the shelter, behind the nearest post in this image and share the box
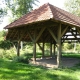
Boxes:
[30,57,80,68]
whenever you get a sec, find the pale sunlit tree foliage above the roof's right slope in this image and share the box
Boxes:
[65,0,80,16]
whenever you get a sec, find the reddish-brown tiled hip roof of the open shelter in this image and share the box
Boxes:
[5,3,80,29]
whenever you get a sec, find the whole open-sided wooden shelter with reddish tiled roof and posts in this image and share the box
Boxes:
[4,3,80,67]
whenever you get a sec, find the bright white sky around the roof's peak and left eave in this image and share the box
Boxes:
[0,0,65,31]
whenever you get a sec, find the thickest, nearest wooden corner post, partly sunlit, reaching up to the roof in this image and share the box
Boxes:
[57,24,61,67]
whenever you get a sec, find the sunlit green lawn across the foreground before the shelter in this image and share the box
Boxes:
[0,59,80,80]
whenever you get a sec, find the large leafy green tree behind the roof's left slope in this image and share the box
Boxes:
[5,0,38,20]
